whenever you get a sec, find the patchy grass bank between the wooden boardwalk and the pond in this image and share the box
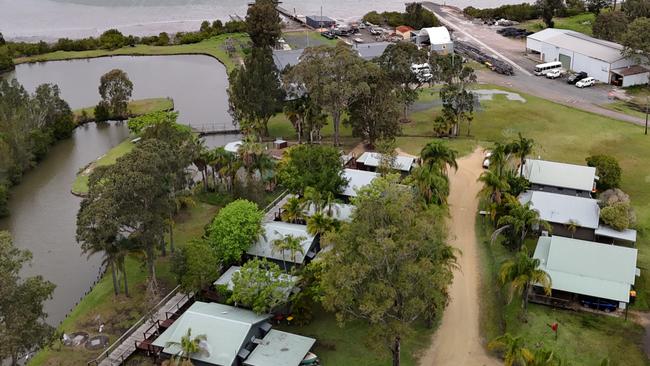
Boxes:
[29,202,219,366]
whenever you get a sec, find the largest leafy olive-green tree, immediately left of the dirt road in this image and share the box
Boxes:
[322,176,455,364]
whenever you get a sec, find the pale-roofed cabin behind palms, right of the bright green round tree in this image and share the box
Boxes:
[246,221,320,268]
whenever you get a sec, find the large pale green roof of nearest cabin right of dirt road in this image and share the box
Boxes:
[533,236,637,302]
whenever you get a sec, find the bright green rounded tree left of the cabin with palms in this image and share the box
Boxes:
[208,199,264,265]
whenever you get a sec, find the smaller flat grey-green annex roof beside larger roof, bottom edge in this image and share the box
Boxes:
[244,329,316,366]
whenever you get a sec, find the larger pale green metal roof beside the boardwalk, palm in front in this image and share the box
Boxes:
[153,301,270,366]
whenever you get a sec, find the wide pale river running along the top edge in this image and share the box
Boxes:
[0,0,526,41]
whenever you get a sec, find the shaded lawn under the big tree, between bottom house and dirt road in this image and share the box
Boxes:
[274,310,434,366]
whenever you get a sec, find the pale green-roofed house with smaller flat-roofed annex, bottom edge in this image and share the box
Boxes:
[153,301,316,366]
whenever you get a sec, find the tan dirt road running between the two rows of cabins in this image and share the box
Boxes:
[420,149,501,366]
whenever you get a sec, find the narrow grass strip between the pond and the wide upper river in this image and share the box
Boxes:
[14,33,248,71]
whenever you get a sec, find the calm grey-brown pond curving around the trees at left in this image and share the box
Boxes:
[0,56,238,324]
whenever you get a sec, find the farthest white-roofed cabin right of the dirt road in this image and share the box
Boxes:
[523,159,598,198]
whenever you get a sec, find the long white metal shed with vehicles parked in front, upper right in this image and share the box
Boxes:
[526,28,649,86]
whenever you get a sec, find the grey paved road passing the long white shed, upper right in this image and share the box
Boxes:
[423,2,645,125]
